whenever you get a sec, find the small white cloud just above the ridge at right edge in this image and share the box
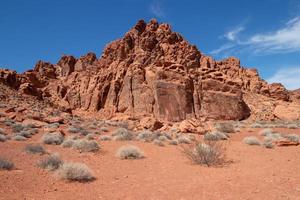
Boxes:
[267,66,300,90]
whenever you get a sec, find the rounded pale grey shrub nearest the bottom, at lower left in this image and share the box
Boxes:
[57,162,95,182]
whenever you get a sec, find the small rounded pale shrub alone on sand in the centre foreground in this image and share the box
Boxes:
[116,145,144,159]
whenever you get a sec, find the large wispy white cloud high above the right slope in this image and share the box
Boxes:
[211,17,300,54]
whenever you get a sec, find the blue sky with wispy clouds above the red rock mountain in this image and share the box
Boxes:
[0,0,300,89]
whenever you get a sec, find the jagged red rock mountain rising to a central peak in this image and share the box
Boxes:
[0,20,300,122]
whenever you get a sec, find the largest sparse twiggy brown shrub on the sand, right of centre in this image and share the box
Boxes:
[183,141,226,167]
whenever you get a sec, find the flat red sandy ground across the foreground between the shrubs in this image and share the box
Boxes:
[0,129,300,200]
